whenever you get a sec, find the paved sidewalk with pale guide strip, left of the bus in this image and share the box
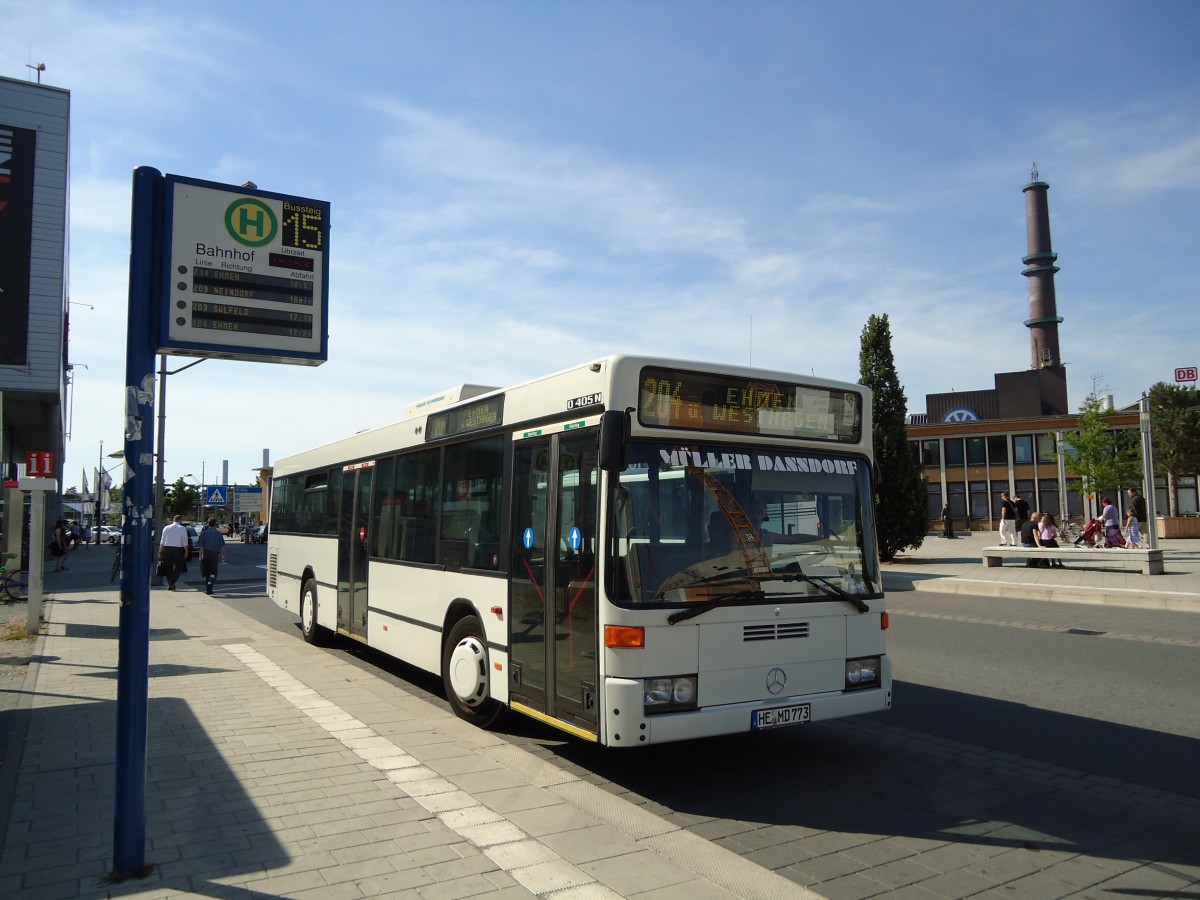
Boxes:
[0,548,818,900]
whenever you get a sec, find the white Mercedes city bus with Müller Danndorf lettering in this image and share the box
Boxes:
[268,356,892,746]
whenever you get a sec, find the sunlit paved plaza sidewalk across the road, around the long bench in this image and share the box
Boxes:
[883,532,1200,612]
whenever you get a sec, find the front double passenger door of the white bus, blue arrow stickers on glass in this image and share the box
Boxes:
[509,428,599,733]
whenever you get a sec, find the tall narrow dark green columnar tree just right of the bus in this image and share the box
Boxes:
[858,313,929,562]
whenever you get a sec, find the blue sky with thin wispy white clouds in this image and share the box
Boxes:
[0,0,1200,494]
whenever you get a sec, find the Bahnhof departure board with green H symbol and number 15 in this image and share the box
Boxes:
[161,175,329,365]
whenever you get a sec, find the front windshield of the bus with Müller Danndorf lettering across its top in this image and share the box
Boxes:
[608,440,882,608]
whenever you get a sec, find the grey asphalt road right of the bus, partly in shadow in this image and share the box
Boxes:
[889,612,1200,797]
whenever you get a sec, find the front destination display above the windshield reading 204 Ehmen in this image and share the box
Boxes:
[637,368,863,443]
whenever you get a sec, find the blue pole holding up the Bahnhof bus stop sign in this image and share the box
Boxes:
[113,166,163,875]
